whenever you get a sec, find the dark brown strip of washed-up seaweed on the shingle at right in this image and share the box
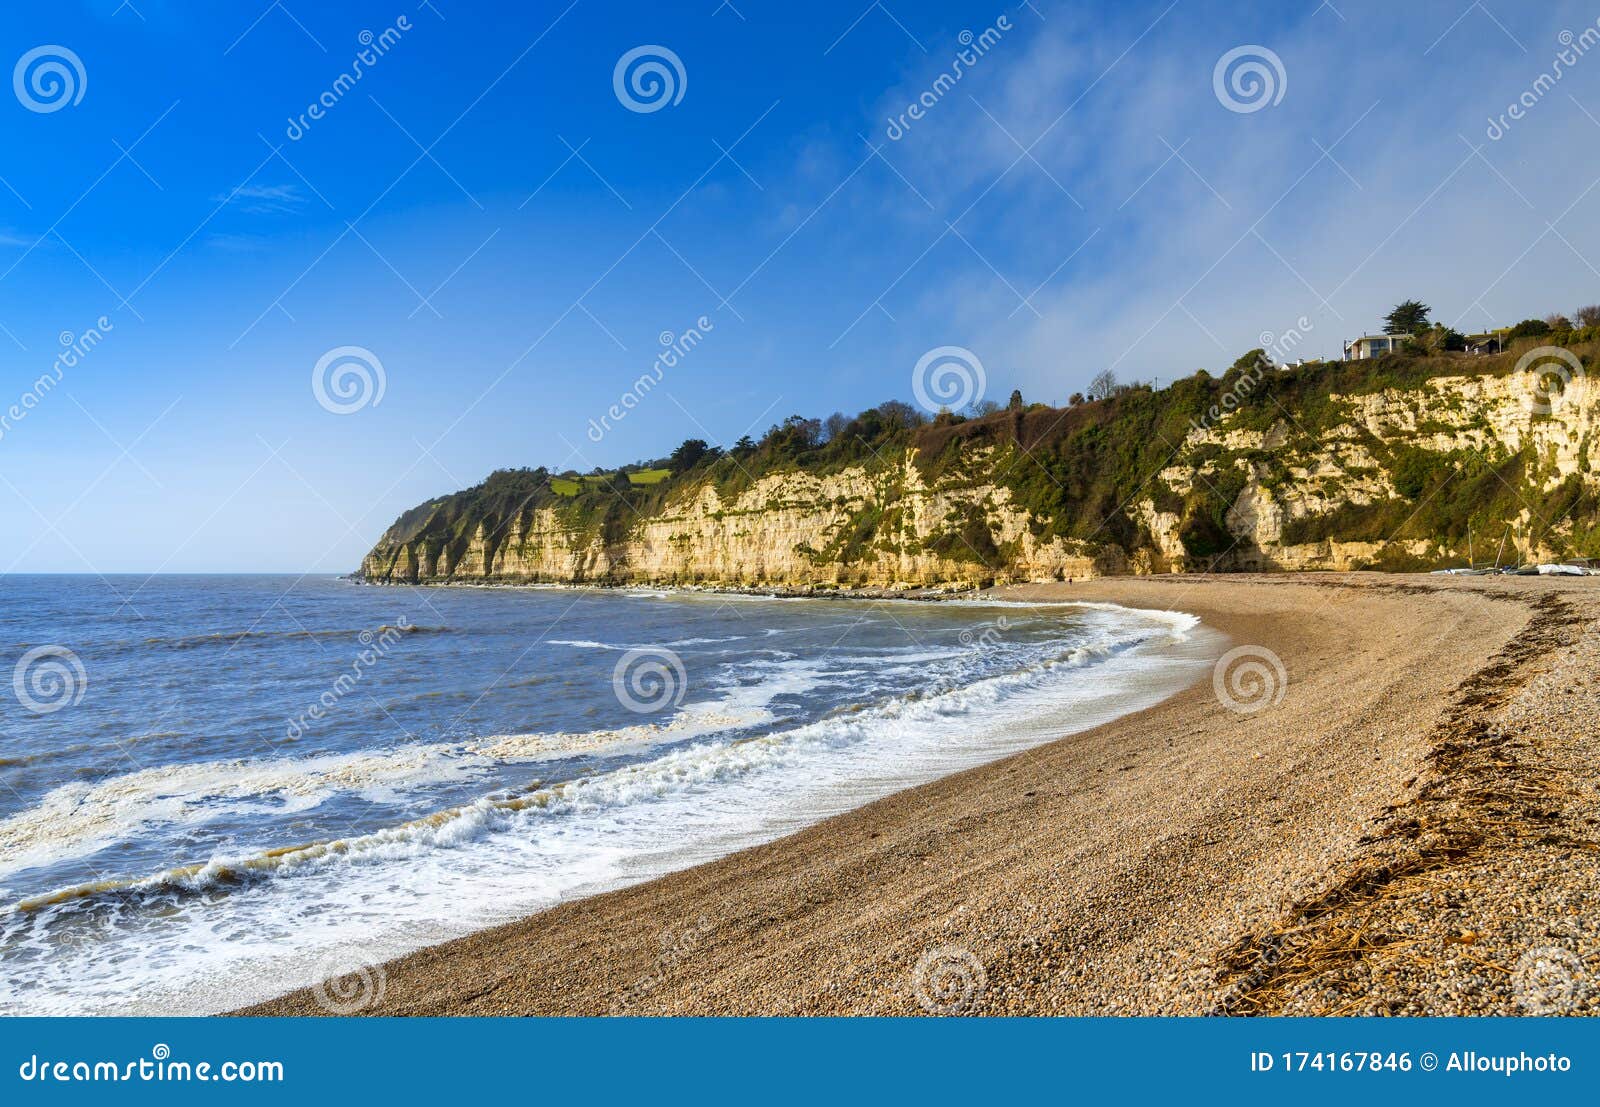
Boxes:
[1211,593,1600,1014]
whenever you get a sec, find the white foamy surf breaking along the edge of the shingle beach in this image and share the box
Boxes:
[0,605,1210,1013]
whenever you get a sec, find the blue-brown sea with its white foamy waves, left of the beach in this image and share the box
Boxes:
[0,576,1219,1014]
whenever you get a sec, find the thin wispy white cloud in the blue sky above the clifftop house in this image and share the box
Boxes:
[844,3,1600,400]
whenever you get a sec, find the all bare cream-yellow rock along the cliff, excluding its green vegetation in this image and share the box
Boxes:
[362,374,1600,589]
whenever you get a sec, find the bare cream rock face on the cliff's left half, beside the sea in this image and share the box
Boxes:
[363,456,1126,587]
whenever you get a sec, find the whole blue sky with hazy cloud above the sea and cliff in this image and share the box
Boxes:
[0,0,1600,574]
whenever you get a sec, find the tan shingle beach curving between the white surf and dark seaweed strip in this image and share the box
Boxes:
[243,574,1600,1014]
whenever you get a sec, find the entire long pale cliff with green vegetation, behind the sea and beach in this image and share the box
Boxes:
[360,355,1600,589]
